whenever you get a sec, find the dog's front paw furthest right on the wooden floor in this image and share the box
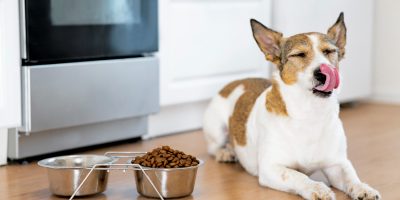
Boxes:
[348,183,382,200]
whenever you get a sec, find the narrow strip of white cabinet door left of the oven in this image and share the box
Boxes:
[0,0,21,128]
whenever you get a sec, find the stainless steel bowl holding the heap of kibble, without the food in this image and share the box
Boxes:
[134,160,203,198]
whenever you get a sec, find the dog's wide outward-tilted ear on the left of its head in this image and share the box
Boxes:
[250,19,282,64]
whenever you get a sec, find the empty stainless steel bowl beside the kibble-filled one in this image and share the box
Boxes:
[38,155,116,196]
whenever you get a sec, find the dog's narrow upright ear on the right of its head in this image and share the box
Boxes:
[328,12,346,60]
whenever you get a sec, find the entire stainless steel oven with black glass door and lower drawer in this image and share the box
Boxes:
[8,0,159,159]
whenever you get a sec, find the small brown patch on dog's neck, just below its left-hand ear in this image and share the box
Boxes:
[265,81,288,116]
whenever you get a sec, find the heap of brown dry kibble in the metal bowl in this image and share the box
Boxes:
[132,146,199,168]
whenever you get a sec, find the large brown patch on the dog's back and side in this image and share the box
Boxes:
[219,78,271,146]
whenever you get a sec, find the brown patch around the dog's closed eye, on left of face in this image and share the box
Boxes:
[278,34,314,85]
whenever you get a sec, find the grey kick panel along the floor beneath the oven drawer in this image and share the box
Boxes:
[7,116,148,160]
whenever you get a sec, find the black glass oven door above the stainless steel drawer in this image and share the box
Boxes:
[22,0,158,65]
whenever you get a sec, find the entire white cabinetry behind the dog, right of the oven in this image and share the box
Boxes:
[149,0,374,137]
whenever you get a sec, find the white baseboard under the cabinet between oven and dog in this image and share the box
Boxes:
[146,101,209,139]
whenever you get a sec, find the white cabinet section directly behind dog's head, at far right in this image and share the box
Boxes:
[272,0,374,102]
